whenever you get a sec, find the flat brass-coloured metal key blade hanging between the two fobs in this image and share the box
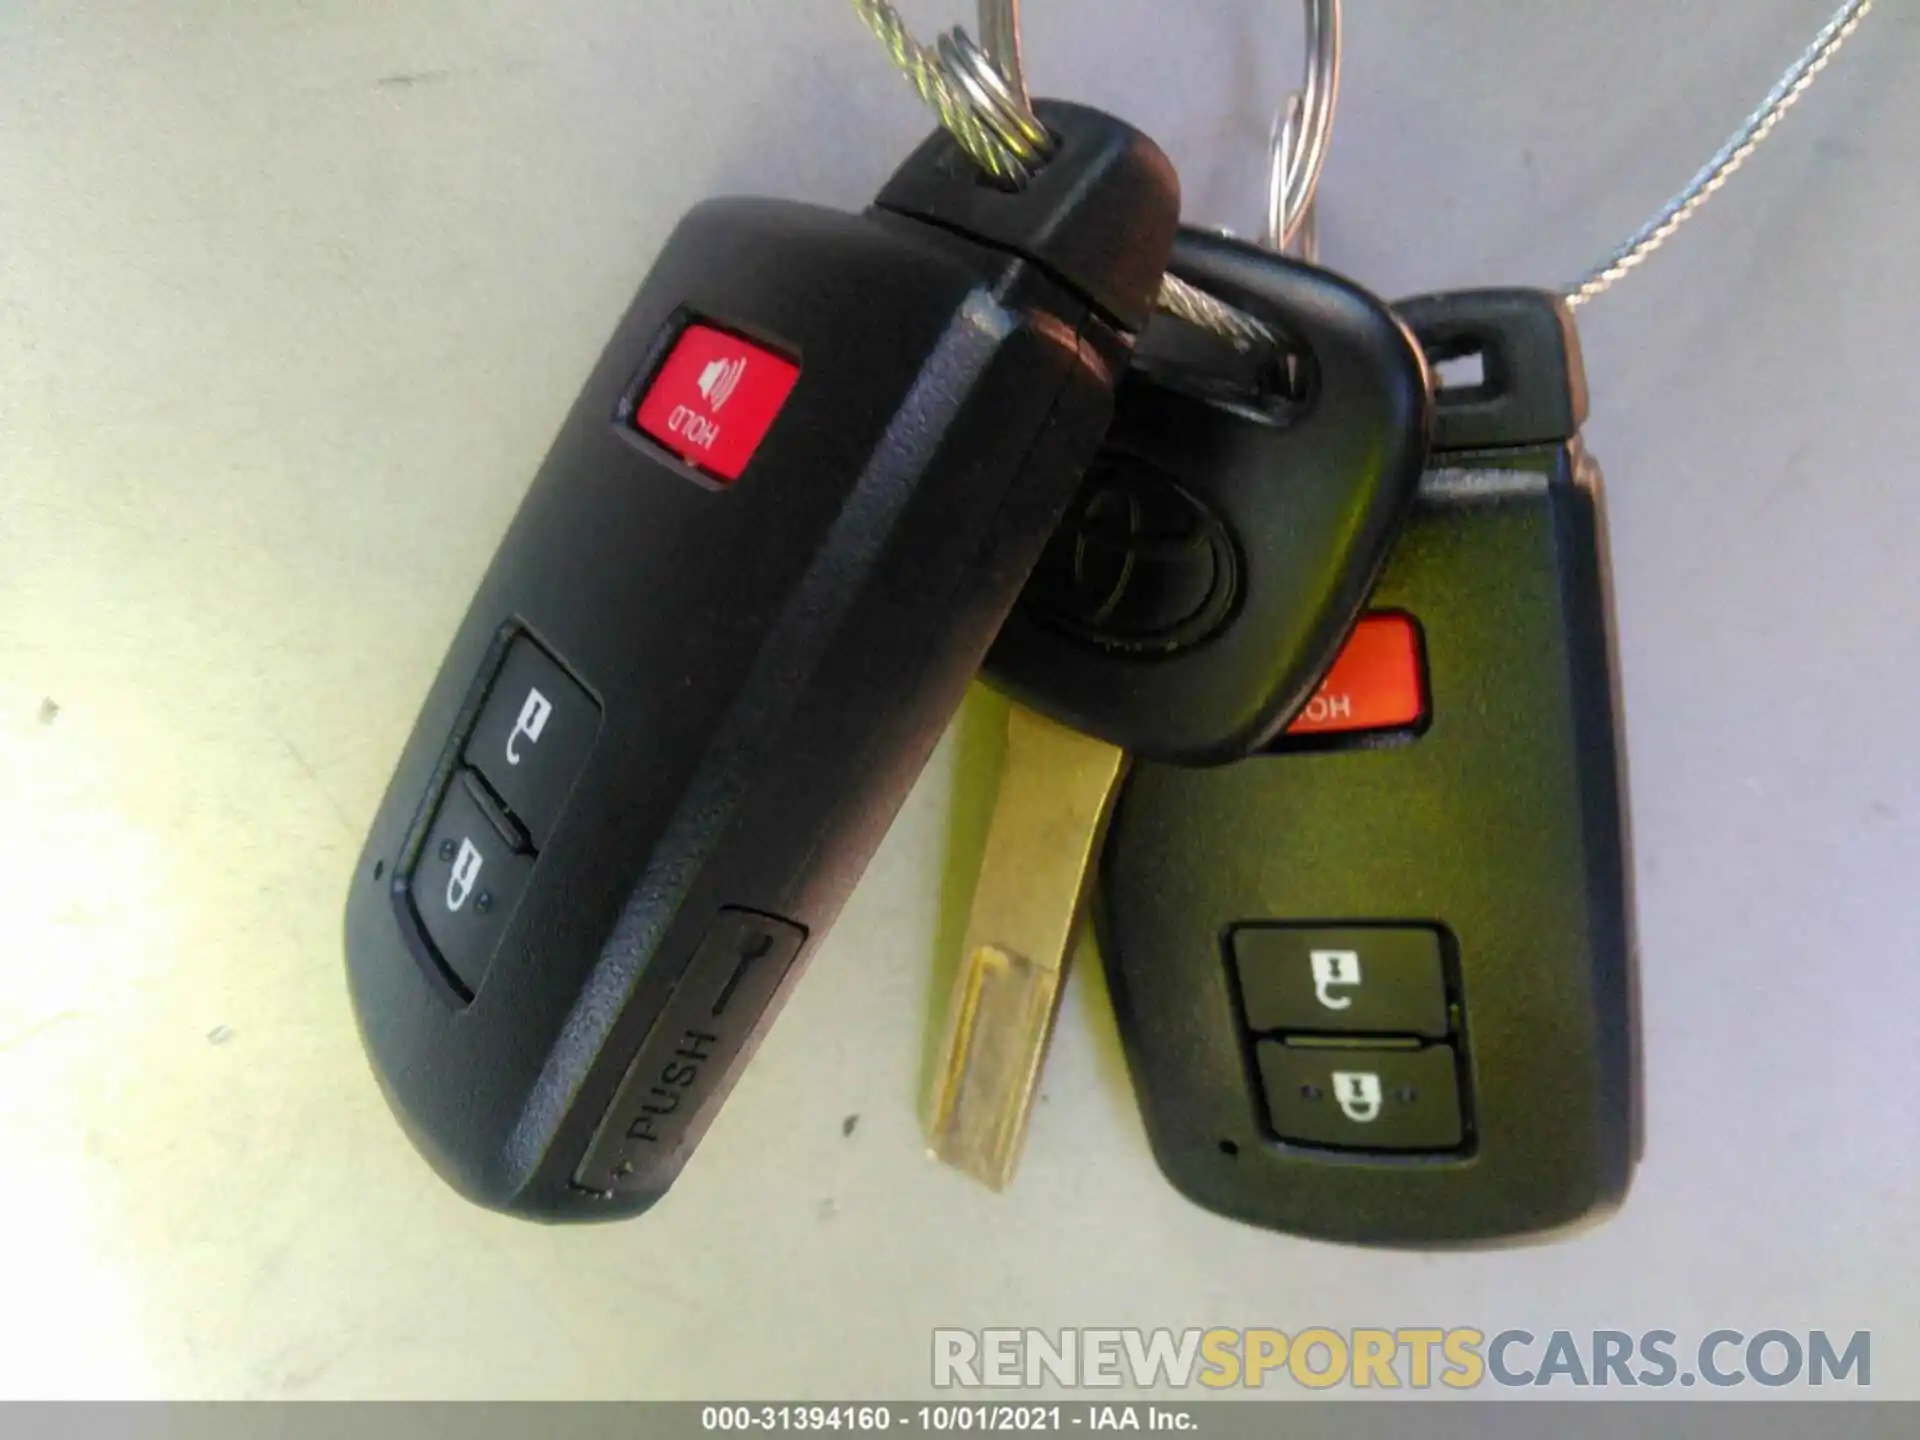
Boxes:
[927,705,1127,1190]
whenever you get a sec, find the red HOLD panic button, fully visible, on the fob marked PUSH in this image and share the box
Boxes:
[634,324,801,480]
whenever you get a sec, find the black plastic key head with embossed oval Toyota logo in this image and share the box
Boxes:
[987,230,1432,764]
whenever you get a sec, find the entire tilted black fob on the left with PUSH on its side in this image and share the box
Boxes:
[346,104,1179,1219]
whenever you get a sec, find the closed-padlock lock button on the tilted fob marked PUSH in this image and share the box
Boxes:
[409,772,534,996]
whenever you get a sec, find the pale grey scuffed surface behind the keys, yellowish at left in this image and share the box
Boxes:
[0,0,1920,1398]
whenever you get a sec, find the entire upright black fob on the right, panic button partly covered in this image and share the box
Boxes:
[1098,292,1638,1246]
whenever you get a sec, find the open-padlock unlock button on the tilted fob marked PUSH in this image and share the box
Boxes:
[467,636,599,849]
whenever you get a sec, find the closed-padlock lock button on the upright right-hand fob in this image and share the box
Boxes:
[1258,1041,1465,1150]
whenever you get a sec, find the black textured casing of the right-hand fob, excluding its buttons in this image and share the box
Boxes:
[1098,292,1640,1246]
